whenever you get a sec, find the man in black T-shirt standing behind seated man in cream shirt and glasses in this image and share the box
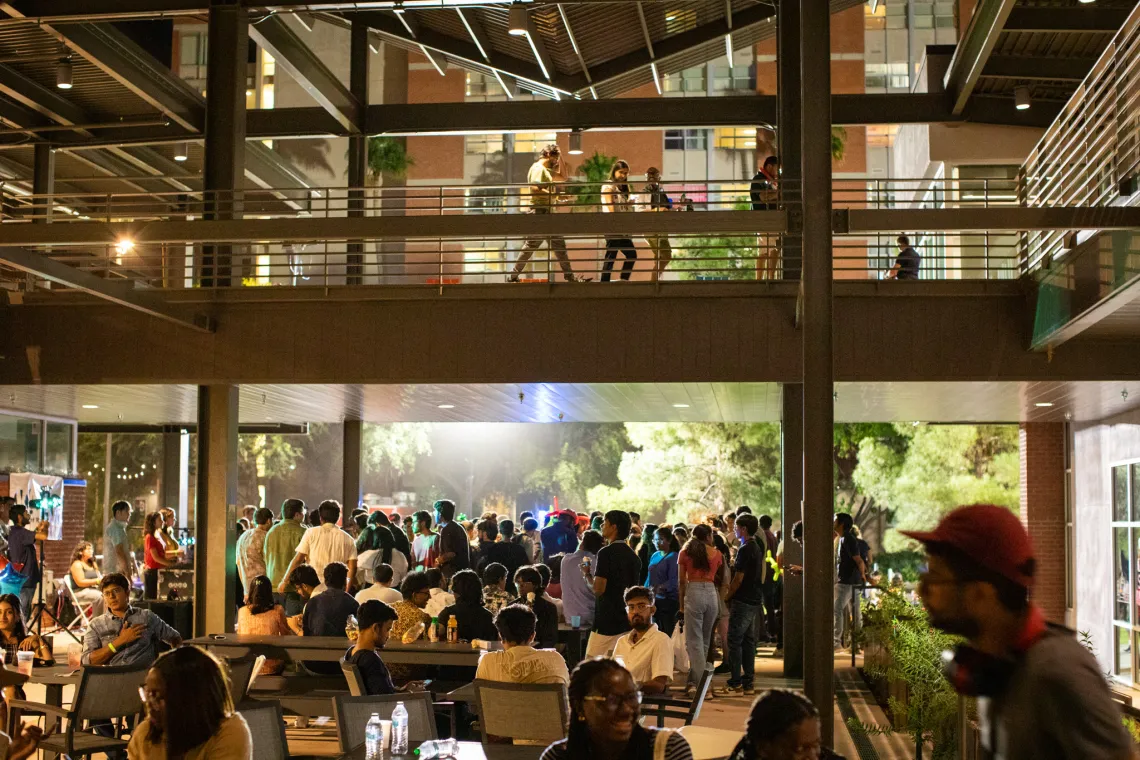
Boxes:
[581,509,641,657]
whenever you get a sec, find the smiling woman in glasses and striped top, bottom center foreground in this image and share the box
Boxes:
[539,657,693,760]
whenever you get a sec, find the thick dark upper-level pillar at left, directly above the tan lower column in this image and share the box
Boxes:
[200,0,250,287]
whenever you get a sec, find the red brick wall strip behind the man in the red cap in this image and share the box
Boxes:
[1019,423,1068,623]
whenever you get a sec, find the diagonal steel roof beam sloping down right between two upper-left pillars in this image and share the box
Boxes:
[250,16,368,133]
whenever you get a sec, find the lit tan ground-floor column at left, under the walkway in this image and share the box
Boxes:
[194,385,237,636]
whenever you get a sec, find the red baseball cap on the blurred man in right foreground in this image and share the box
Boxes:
[898,504,1034,589]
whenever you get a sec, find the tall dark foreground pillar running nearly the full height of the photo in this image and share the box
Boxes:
[799,0,834,746]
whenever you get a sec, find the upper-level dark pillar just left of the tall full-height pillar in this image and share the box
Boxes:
[776,0,804,280]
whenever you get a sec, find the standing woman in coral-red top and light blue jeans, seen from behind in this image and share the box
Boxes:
[677,518,720,696]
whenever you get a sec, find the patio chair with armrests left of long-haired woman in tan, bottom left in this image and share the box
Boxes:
[8,665,149,758]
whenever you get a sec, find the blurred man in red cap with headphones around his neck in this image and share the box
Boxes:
[901,505,1137,760]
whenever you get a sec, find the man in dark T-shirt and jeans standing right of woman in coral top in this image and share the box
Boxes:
[713,515,767,696]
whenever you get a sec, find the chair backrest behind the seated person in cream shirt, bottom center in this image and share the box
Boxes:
[473,680,570,744]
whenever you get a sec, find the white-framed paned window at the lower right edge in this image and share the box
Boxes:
[1110,461,1140,683]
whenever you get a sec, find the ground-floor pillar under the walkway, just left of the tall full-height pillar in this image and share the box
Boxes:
[780,383,804,678]
